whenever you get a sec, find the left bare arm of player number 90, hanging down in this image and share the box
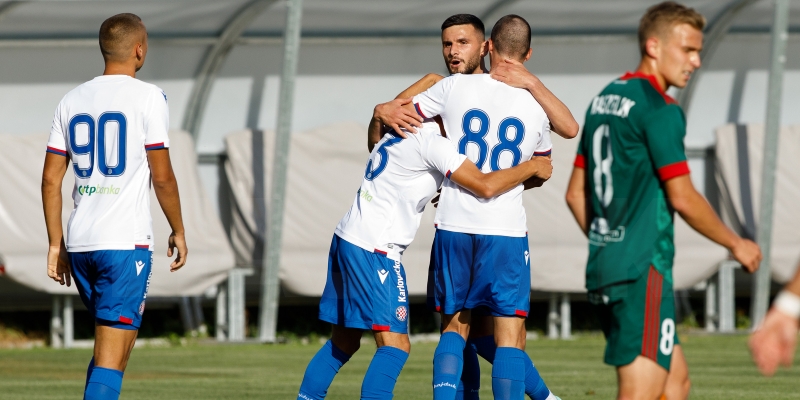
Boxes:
[42,153,72,286]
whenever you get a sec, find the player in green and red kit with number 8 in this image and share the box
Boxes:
[567,2,761,400]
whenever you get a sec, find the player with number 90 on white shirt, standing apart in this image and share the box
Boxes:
[42,14,187,399]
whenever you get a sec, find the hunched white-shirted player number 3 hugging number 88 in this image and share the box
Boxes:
[297,120,552,400]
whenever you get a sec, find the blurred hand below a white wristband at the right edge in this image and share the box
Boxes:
[748,307,798,376]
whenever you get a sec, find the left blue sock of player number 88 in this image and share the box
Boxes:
[433,332,466,400]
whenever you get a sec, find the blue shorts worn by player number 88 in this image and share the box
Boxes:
[428,229,531,317]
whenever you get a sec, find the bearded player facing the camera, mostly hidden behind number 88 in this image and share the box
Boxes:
[368,14,578,400]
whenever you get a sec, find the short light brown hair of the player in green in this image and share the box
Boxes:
[639,1,706,56]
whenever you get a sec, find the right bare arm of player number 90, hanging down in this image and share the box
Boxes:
[147,149,189,272]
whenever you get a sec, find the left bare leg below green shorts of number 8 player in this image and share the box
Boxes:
[617,356,667,400]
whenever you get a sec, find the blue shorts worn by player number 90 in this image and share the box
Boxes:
[69,249,153,330]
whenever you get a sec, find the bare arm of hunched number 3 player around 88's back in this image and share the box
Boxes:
[450,157,553,198]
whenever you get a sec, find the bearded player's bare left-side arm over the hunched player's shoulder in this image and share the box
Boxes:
[367,74,444,151]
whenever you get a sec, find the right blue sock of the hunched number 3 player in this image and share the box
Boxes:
[361,346,408,400]
